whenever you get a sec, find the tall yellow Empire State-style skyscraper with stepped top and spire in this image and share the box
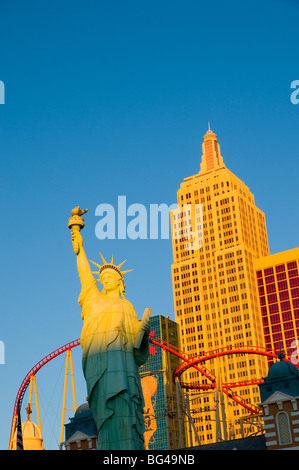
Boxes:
[171,129,269,444]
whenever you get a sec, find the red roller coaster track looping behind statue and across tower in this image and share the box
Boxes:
[7,333,296,448]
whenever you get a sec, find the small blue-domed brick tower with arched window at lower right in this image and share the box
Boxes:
[259,353,299,450]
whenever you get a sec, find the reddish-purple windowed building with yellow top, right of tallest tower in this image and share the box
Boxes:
[255,248,299,360]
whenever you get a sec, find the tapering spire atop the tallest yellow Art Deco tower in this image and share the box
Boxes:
[200,123,224,173]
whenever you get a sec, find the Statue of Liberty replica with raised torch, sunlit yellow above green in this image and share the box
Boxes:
[68,207,151,450]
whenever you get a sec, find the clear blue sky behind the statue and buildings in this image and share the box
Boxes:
[0,0,299,449]
